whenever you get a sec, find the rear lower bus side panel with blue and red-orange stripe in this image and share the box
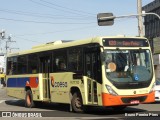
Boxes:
[6,75,39,99]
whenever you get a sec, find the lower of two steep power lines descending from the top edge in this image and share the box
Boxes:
[30,0,93,17]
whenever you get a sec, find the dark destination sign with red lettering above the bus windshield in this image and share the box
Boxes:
[103,38,149,47]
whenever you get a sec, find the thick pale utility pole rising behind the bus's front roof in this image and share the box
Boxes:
[137,0,144,37]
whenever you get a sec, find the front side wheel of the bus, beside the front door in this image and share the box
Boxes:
[71,93,83,113]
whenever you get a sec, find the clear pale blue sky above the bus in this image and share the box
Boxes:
[0,0,153,52]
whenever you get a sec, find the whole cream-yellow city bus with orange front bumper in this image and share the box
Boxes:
[6,36,155,112]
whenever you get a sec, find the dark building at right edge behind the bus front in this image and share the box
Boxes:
[142,0,160,78]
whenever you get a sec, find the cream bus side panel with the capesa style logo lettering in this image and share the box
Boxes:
[50,72,73,103]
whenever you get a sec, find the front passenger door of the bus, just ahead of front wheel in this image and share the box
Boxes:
[85,51,101,104]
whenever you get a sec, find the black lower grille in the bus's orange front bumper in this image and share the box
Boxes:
[121,96,147,103]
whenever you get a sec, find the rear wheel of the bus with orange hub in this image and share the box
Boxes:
[25,90,35,108]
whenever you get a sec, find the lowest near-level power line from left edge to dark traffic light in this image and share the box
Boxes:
[0,17,95,24]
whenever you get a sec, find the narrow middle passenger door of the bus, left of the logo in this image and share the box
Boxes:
[40,56,50,100]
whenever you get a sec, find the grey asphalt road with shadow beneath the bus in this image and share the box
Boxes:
[0,88,160,120]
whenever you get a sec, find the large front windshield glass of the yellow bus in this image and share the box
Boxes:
[105,49,152,83]
